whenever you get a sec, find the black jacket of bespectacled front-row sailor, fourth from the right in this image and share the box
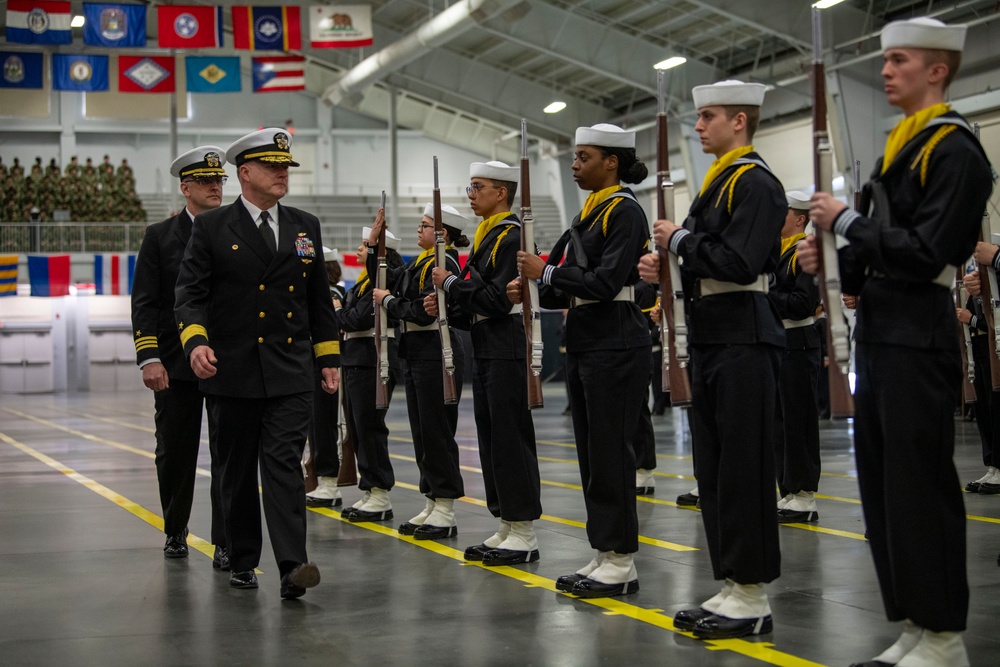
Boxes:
[445,213,525,359]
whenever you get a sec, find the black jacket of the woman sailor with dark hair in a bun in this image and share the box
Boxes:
[539,188,650,353]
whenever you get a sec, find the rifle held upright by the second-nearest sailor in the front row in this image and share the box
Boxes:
[656,70,691,407]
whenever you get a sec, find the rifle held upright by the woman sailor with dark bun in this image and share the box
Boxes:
[520,118,545,409]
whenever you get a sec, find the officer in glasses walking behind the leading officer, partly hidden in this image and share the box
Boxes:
[132,146,229,570]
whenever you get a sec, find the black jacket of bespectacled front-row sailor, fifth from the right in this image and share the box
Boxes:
[367,248,462,359]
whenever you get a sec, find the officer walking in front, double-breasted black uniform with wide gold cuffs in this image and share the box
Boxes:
[175,128,340,598]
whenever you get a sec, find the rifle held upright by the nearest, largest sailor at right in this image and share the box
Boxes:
[812,7,854,419]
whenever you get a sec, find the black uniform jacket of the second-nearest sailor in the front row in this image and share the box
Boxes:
[670,152,788,348]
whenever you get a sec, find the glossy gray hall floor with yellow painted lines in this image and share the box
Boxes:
[0,384,1000,667]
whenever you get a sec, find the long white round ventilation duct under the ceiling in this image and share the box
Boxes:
[323,0,521,106]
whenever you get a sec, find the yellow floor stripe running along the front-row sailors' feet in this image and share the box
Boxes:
[309,507,824,667]
